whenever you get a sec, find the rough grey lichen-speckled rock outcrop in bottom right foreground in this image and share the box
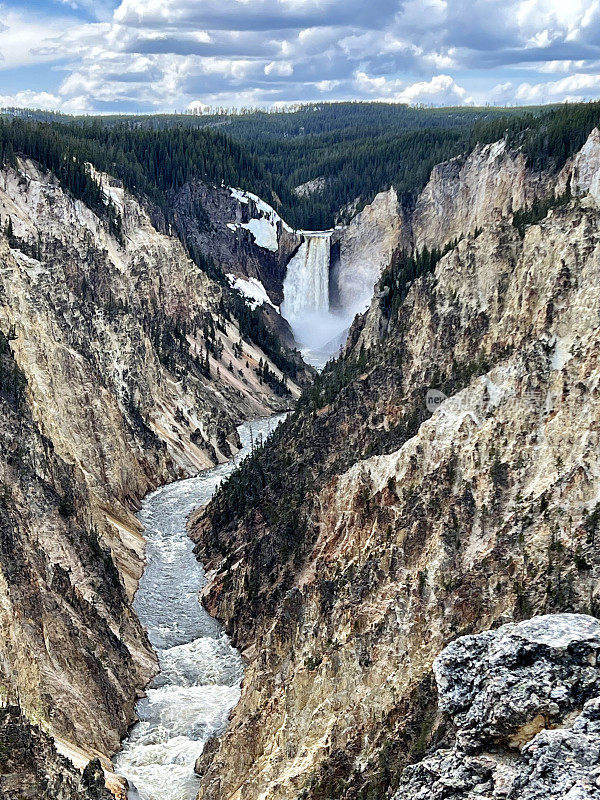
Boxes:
[394,614,600,800]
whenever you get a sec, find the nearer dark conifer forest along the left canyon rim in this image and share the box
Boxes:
[0,115,273,219]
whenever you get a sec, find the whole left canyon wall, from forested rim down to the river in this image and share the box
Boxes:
[0,161,299,784]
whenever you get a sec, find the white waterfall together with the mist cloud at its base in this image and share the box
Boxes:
[281,231,354,366]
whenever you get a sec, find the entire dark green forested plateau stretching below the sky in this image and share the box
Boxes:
[0,103,600,229]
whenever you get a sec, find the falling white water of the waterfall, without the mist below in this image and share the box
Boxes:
[282,231,331,318]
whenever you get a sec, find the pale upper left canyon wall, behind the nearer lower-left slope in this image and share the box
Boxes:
[0,164,297,588]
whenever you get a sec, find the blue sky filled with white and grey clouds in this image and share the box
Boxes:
[0,0,600,114]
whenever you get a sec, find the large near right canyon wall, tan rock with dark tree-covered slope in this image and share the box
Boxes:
[193,130,600,800]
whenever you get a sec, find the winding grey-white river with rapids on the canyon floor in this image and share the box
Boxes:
[114,415,285,800]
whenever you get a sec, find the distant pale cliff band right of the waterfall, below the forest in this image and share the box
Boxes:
[331,141,552,326]
